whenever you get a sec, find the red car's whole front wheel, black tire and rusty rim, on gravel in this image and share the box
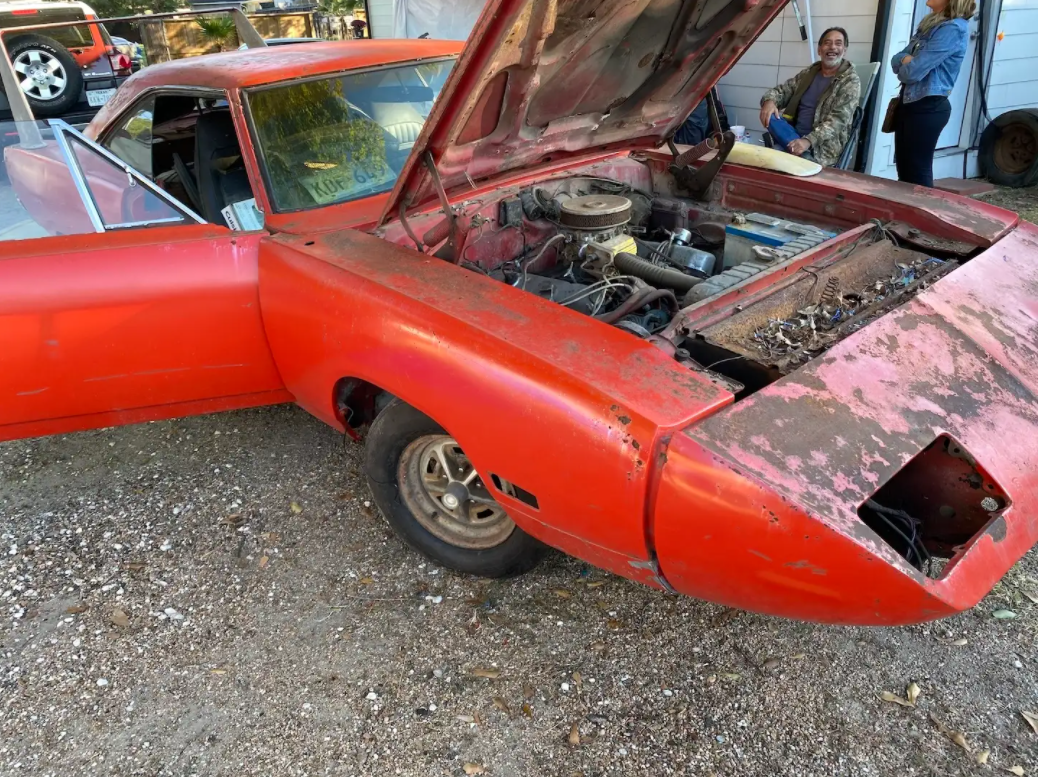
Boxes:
[364,399,547,578]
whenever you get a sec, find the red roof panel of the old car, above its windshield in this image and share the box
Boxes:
[125,38,464,91]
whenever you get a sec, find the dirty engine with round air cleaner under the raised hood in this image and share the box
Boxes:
[490,179,832,339]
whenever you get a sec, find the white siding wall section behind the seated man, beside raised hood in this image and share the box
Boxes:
[718,0,880,142]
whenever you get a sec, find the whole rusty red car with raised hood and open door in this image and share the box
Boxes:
[0,0,1038,625]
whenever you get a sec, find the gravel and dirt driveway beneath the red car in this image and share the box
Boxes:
[0,407,1038,777]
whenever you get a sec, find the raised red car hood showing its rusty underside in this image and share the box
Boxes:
[382,0,787,221]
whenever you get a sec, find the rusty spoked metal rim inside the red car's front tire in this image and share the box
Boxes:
[399,435,516,550]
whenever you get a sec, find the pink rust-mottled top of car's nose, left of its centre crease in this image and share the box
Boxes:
[686,288,1038,561]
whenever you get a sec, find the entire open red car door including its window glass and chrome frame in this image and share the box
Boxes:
[0,116,291,440]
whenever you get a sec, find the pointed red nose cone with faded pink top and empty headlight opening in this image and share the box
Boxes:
[653,224,1038,625]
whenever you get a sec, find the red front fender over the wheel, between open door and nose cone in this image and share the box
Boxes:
[260,230,733,585]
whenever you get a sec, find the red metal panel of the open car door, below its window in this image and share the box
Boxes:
[0,224,291,440]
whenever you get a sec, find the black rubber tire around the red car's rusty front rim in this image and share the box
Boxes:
[364,399,547,578]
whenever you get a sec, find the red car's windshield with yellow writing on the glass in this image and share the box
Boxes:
[248,59,454,212]
